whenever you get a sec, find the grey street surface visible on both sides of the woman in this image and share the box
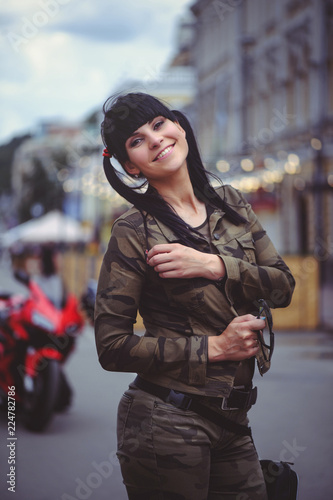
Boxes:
[0,262,333,500]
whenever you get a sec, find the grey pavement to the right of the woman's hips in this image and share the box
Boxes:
[249,331,333,500]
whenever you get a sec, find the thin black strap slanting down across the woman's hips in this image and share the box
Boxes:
[134,376,252,436]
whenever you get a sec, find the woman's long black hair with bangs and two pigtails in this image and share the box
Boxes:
[101,92,246,247]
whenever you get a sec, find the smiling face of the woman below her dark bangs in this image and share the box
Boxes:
[124,116,188,185]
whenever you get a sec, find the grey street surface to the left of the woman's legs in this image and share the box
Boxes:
[0,327,133,500]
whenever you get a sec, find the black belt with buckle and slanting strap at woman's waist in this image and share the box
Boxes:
[134,376,257,436]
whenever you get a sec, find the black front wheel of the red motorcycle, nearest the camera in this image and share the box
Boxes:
[23,359,61,432]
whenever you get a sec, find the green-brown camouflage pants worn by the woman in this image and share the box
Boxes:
[117,385,267,500]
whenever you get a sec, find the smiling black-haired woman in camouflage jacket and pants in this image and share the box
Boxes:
[95,93,294,500]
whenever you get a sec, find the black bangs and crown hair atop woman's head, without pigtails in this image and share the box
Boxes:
[101,92,177,162]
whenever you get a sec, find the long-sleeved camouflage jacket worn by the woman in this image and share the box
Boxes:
[95,186,295,397]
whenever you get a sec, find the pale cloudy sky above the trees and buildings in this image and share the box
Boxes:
[0,0,194,144]
